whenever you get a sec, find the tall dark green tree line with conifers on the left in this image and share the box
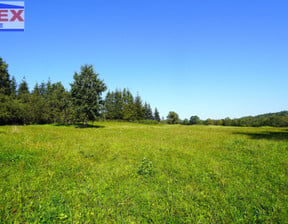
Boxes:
[0,58,160,125]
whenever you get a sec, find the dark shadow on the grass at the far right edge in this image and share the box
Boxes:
[233,130,288,141]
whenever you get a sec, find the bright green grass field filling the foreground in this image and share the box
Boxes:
[0,122,288,223]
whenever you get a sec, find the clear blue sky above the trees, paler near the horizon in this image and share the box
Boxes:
[0,0,288,119]
